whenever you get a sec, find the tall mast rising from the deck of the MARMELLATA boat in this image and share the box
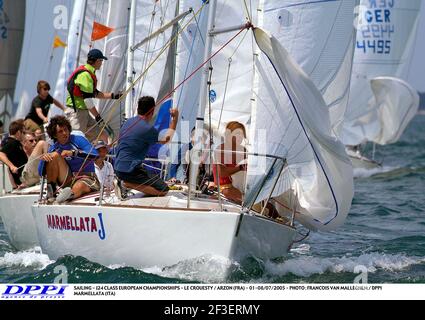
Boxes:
[188,0,217,202]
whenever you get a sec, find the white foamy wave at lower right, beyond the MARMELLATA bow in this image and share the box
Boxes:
[265,253,425,278]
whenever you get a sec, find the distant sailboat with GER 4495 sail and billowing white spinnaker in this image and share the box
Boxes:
[341,0,422,169]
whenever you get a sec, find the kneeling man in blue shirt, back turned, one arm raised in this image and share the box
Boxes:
[115,97,179,196]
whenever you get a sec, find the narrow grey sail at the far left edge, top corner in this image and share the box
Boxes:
[0,0,25,130]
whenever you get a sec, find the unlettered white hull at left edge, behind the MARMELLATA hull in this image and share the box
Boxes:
[0,194,39,250]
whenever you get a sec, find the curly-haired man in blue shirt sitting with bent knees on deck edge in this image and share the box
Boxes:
[39,116,100,203]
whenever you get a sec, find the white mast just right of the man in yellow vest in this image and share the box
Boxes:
[125,0,137,119]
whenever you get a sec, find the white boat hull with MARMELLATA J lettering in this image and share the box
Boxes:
[32,201,296,268]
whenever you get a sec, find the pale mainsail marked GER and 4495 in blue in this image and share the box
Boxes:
[342,0,422,145]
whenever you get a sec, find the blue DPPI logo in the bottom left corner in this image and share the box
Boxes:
[1,285,68,299]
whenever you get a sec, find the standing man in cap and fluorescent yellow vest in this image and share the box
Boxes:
[65,49,122,141]
